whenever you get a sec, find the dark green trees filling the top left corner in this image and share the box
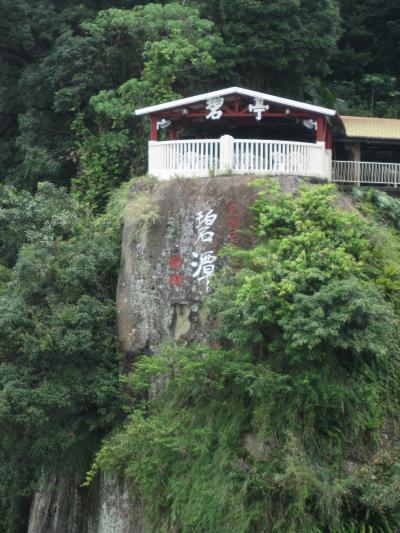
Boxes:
[0,0,150,190]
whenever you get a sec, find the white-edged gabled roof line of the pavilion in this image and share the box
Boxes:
[135,87,337,117]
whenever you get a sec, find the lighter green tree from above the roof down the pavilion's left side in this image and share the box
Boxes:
[73,3,227,208]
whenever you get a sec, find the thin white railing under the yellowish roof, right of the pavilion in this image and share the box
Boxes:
[332,161,400,187]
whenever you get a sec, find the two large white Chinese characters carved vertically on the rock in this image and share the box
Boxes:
[190,209,218,290]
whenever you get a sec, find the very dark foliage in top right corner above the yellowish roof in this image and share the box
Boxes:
[330,0,400,117]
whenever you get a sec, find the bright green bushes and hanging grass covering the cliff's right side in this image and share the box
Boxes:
[93,186,400,533]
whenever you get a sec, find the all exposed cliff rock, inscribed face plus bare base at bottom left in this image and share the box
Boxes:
[28,176,300,533]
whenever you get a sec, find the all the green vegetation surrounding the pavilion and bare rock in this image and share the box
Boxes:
[0,0,400,533]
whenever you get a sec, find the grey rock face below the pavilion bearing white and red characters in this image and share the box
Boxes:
[117,176,256,354]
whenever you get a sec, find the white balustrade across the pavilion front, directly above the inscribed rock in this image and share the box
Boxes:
[149,135,331,179]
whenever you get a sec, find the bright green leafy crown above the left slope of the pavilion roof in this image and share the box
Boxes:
[84,3,222,99]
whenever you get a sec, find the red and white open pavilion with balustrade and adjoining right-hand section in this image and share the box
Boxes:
[135,87,400,186]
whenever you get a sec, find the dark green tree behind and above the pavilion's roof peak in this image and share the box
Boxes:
[194,0,339,98]
